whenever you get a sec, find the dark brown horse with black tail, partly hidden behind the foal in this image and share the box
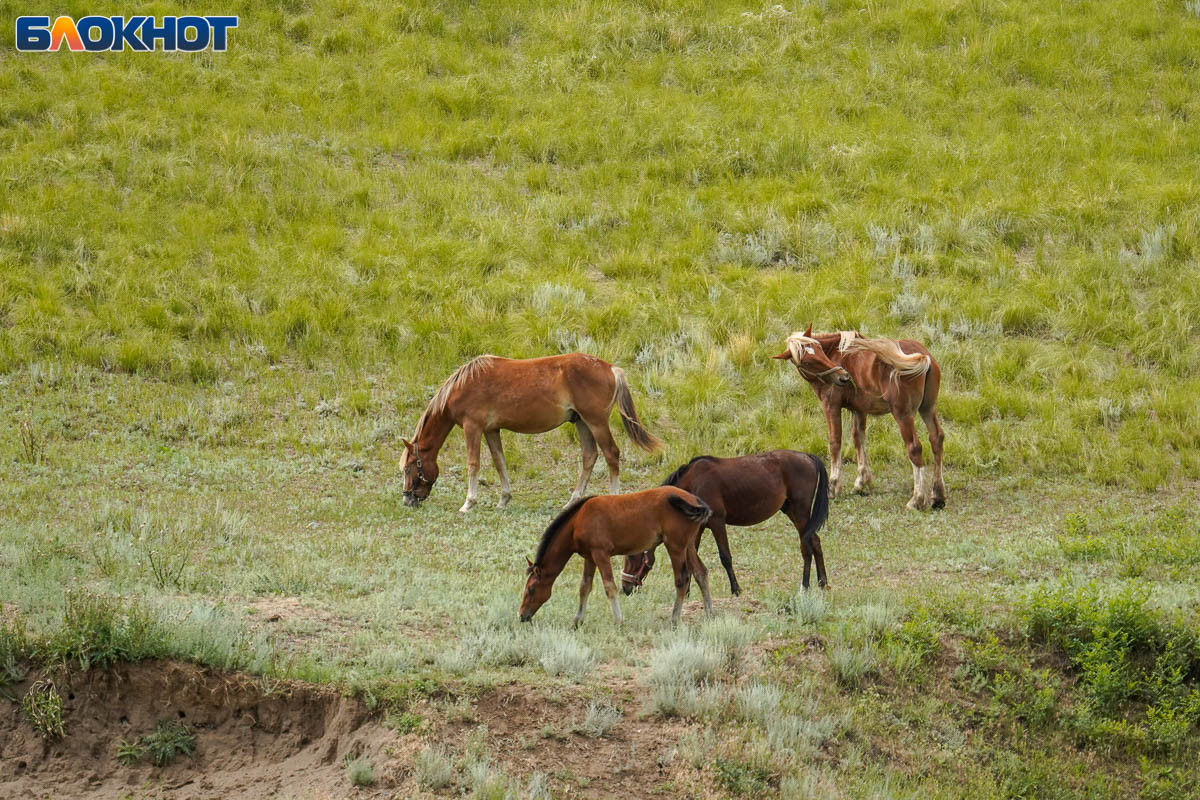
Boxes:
[620,450,829,595]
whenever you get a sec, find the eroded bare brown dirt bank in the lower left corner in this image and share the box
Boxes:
[0,661,396,800]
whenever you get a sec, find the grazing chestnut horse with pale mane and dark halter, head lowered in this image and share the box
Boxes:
[401,353,661,512]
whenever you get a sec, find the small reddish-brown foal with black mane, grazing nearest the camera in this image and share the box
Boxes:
[521,486,713,627]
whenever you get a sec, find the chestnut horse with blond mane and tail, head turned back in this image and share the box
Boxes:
[775,325,946,510]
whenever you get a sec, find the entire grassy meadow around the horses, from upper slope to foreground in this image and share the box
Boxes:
[0,0,1200,800]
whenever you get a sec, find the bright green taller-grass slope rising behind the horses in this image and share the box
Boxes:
[0,0,1200,487]
